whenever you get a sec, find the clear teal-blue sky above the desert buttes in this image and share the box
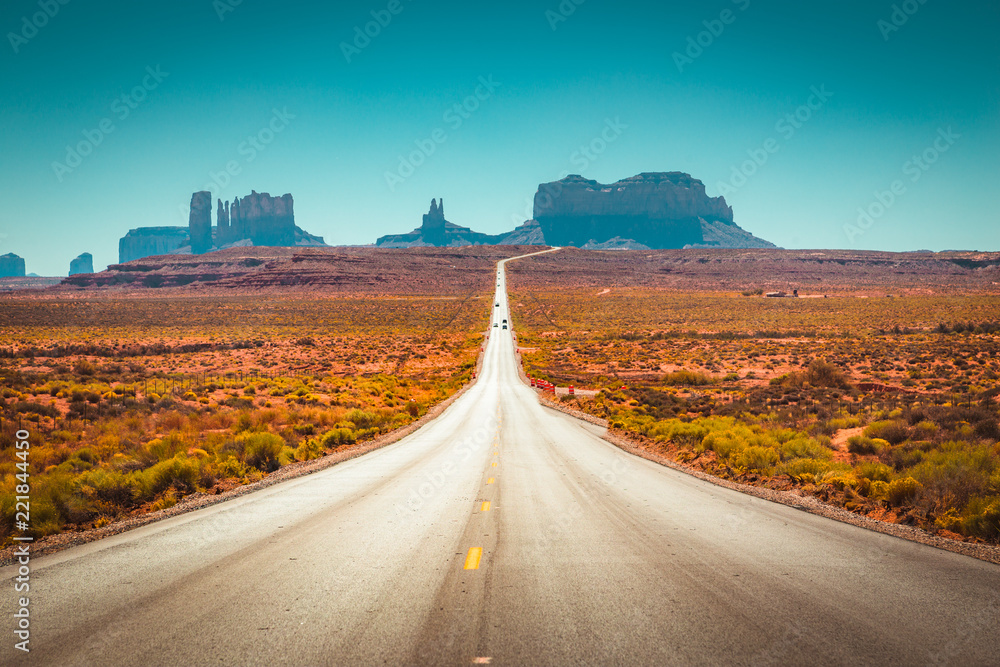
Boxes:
[0,0,1000,275]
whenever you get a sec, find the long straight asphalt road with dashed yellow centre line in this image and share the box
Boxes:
[0,253,1000,665]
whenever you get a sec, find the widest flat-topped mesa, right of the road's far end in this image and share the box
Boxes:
[535,172,774,249]
